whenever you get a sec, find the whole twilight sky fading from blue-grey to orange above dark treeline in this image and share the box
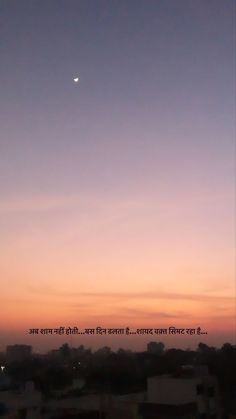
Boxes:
[0,0,236,351]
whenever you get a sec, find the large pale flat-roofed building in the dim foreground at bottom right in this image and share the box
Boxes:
[144,367,221,419]
